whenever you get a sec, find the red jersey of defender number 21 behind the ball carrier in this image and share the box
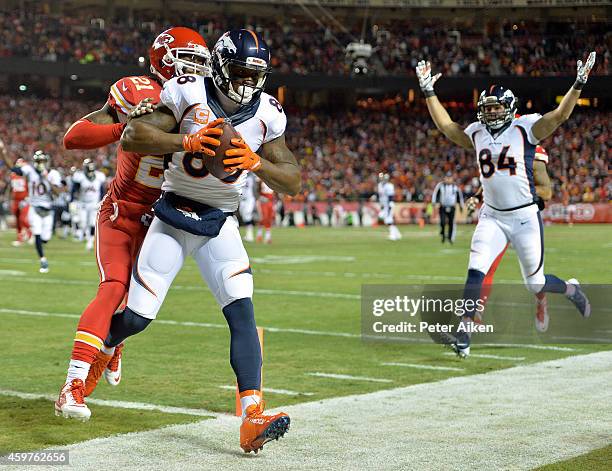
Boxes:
[107,76,164,205]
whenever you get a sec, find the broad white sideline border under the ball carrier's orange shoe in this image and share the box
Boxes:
[40,351,612,471]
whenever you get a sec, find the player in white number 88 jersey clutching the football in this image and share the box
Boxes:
[113,29,301,452]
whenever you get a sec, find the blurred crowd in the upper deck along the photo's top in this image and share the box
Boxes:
[0,12,612,76]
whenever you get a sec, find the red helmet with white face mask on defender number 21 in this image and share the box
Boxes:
[149,26,210,82]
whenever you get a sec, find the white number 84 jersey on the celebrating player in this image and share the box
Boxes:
[465,114,541,211]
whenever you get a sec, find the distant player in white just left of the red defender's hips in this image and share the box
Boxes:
[72,159,106,250]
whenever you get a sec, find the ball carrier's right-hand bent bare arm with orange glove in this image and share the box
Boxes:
[223,134,302,196]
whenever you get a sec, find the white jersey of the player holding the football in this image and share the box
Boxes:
[160,75,287,212]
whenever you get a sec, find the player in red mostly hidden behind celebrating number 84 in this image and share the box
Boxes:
[466,146,552,332]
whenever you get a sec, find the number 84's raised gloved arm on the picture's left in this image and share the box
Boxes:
[416,61,474,149]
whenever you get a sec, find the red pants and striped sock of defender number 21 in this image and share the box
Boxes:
[71,199,146,364]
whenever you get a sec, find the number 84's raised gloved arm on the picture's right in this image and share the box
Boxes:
[531,51,595,141]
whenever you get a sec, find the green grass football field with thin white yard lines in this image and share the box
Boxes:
[0,225,612,469]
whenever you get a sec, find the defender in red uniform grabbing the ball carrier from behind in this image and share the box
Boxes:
[55,27,210,420]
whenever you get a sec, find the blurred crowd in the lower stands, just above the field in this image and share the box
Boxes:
[0,96,612,206]
